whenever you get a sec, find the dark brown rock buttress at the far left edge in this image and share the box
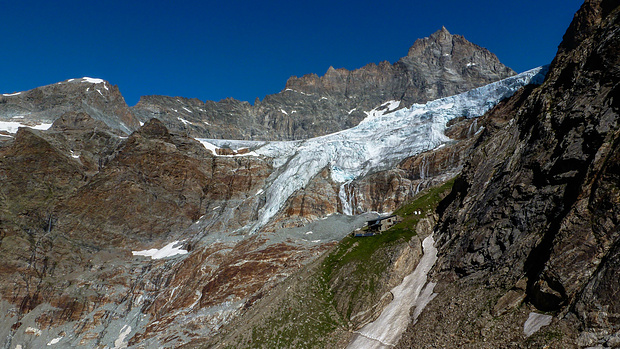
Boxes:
[0,128,85,312]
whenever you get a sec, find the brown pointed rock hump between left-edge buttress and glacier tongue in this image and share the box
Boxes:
[54,119,269,244]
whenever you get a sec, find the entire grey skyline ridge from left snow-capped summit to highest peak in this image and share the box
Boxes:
[0,27,514,140]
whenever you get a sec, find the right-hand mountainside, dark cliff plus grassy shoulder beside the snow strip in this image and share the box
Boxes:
[185,0,620,348]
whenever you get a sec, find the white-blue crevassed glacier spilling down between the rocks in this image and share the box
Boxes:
[200,67,546,232]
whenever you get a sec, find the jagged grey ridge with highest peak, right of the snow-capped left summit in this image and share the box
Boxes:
[132,28,514,140]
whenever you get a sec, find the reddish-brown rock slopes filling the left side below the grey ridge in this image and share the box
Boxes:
[0,118,278,347]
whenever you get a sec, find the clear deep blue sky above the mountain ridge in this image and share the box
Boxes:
[0,0,583,105]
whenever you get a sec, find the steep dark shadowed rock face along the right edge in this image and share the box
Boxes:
[392,0,620,346]
